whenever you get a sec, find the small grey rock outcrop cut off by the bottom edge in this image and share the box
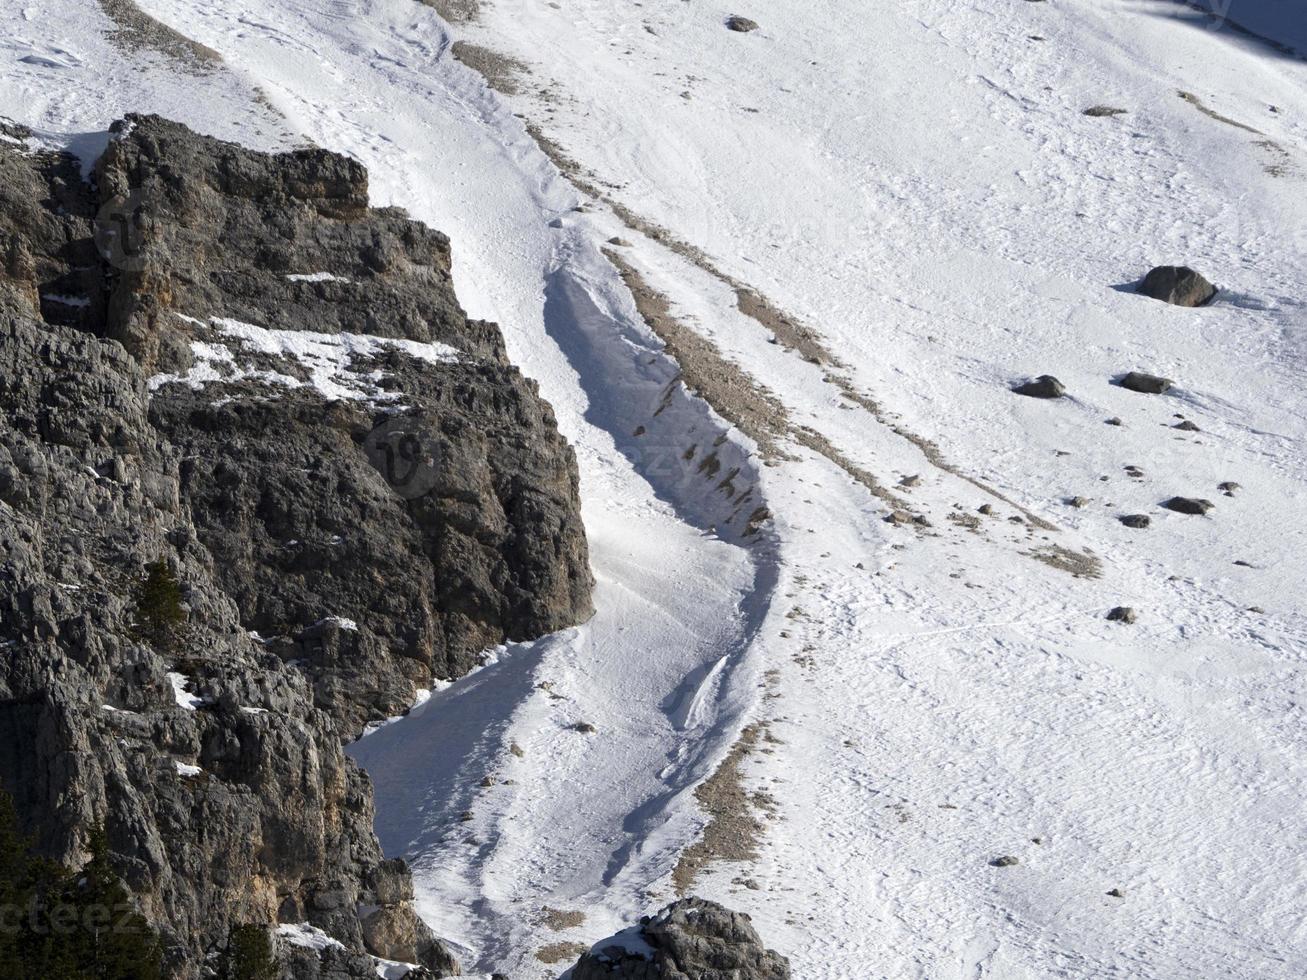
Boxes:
[571,898,789,980]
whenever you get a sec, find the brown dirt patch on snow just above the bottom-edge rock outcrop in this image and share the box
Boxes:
[672,721,776,895]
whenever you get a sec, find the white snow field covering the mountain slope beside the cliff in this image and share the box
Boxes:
[0,0,1307,980]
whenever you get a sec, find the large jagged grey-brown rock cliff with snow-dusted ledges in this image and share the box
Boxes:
[0,118,591,980]
